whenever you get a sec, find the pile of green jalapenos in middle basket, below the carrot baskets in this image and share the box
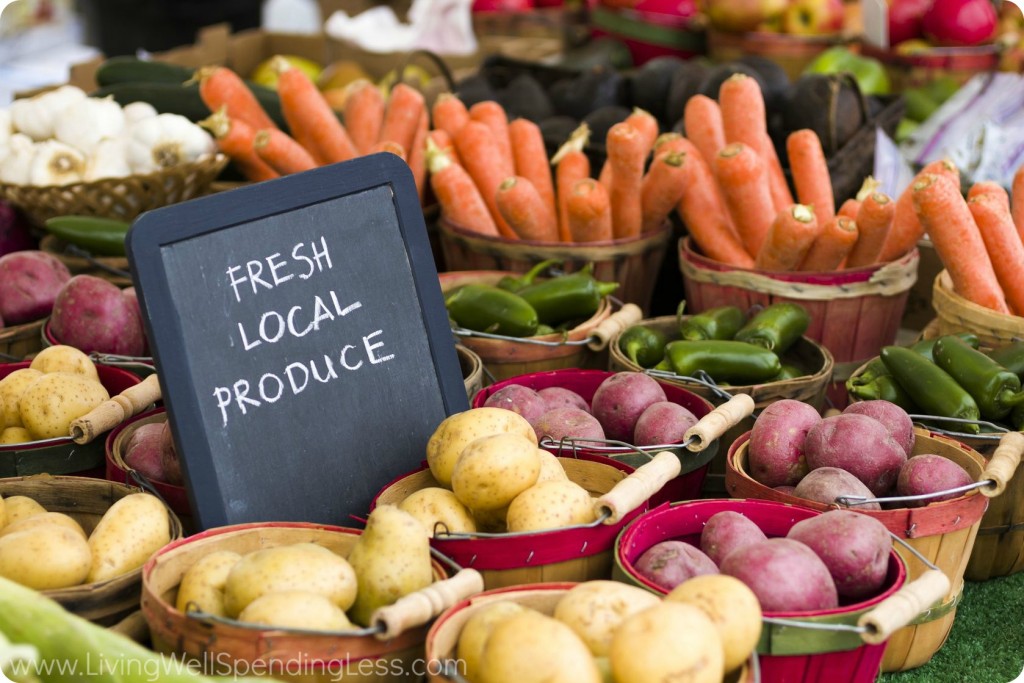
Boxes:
[618,302,810,385]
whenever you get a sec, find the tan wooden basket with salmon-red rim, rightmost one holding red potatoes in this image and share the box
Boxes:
[725,428,988,672]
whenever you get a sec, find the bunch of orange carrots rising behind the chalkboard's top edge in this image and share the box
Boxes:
[197,59,429,199]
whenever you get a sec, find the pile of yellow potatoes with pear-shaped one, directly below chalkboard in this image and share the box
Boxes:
[175,505,434,631]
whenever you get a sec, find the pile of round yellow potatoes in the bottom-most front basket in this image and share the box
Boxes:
[455,575,761,683]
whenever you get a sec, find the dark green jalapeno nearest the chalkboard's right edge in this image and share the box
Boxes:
[444,284,539,337]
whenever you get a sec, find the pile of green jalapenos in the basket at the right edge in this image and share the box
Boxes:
[846,334,1024,434]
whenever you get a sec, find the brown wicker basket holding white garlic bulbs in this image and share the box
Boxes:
[0,154,227,225]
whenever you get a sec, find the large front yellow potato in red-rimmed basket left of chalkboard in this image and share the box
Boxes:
[18,373,111,439]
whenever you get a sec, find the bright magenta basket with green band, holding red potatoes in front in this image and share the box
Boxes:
[613,499,907,683]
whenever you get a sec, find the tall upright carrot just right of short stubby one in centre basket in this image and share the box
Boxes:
[605,121,649,240]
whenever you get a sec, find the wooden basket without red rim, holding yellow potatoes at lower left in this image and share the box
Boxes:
[0,474,182,626]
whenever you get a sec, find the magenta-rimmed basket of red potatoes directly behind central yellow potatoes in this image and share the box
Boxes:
[472,370,719,506]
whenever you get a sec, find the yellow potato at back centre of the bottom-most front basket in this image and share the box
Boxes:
[555,581,662,657]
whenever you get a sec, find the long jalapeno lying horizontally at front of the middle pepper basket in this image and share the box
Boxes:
[665,339,782,384]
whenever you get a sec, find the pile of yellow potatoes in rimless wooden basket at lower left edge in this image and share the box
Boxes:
[0,494,171,591]
